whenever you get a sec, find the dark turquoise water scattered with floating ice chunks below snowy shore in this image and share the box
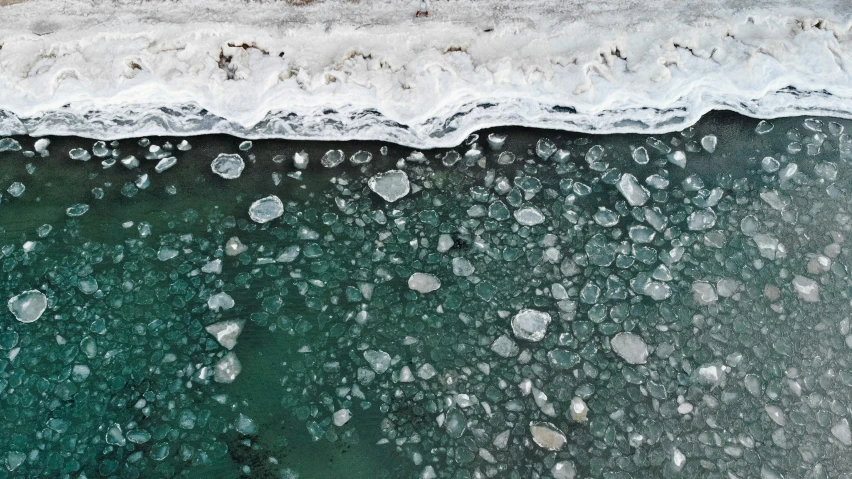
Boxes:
[0,113,852,478]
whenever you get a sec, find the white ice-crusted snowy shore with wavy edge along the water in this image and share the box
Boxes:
[0,0,852,148]
